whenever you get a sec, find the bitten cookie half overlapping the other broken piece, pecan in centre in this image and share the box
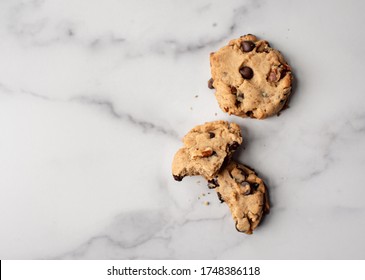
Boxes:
[172,121,242,181]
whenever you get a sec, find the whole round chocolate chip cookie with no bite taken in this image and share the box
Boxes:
[208,34,293,119]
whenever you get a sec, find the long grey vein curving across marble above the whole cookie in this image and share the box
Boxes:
[4,0,262,58]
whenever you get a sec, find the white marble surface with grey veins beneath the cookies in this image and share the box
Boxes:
[0,0,365,259]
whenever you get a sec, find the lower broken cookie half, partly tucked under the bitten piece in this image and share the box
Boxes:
[208,161,270,234]
